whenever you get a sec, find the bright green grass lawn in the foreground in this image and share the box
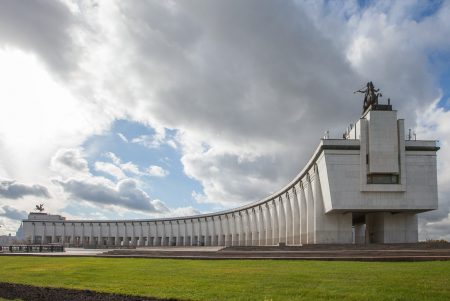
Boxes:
[0,256,450,301]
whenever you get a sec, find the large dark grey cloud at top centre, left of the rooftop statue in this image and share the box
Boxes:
[118,1,360,143]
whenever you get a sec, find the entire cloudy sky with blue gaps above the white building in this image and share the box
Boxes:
[0,0,450,239]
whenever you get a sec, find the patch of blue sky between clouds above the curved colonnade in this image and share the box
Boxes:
[83,120,218,211]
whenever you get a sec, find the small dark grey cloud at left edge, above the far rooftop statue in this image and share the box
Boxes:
[0,180,50,199]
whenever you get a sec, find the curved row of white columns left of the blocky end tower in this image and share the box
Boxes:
[31,147,323,247]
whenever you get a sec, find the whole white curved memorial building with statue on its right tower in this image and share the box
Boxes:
[23,84,439,244]
